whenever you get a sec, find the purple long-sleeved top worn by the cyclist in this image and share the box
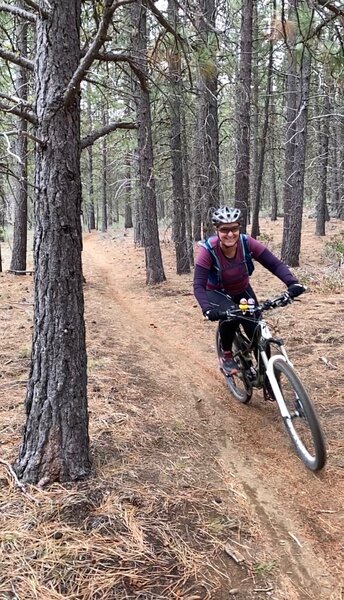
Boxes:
[194,235,298,312]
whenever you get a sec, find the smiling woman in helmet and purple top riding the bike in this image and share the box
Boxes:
[194,206,305,376]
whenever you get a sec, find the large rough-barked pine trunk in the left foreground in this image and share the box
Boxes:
[16,0,90,483]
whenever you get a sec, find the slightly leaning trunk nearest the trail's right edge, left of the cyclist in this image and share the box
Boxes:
[132,3,165,285]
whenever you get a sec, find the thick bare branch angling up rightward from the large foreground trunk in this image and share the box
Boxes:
[64,0,135,107]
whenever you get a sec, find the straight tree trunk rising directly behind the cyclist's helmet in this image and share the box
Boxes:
[235,0,253,231]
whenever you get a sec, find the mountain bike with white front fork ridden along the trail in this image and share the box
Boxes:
[216,292,326,471]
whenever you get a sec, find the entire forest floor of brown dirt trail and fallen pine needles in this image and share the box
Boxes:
[0,219,344,600]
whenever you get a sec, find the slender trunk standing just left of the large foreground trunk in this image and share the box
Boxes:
[10,1,28,274]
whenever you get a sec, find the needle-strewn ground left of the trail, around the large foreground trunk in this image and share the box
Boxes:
[0,250,268,600]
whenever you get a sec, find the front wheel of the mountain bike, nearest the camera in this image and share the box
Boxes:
[273,360,326,471]
